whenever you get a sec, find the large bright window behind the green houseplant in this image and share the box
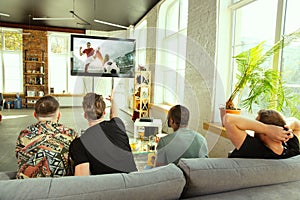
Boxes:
[230,0,300,113]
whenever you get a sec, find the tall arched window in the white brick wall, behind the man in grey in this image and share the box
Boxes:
[154,0,188,104]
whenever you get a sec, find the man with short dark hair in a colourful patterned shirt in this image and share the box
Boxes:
[16,95,78,179]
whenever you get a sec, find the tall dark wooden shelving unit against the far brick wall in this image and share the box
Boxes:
[23,50,48,107]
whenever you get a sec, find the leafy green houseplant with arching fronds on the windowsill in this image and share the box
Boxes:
[225,28,300,116]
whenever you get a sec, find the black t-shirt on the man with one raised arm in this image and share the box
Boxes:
[70,117,137,175]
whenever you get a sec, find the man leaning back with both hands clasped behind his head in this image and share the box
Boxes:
[224,110,300,159]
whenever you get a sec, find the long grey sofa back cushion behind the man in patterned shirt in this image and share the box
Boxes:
[0,164,186,200]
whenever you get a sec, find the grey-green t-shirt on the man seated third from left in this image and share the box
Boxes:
[156,128,208,165]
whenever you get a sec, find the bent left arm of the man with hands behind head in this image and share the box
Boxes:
[223,114,291,149]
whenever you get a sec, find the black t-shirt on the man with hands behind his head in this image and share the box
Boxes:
[228,135,300,159]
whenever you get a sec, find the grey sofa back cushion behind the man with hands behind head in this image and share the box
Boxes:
[178,156,300,198]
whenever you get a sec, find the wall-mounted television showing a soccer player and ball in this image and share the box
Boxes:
[71,34,135,78]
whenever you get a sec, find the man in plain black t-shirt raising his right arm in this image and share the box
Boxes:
[70,90,137,176]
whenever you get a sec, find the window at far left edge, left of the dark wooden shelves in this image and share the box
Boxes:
[0,28,23,93]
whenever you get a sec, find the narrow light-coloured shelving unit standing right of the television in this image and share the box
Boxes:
[133,71,151,118]
